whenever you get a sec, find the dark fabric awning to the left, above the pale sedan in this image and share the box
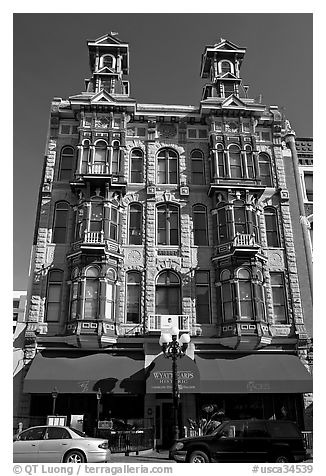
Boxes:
[24,351,145,394]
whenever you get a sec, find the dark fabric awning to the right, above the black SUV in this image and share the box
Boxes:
[195,354,312,393]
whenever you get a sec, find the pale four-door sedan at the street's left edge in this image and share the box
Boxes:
[14,426,111,463]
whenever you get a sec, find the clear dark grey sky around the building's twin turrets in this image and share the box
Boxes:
[13,13,313,290]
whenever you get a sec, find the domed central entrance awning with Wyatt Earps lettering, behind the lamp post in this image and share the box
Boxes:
[146,355,200,393]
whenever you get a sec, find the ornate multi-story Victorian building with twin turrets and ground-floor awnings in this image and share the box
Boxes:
[16,35,311,445]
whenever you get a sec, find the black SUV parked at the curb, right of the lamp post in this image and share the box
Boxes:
[170,420,306,463]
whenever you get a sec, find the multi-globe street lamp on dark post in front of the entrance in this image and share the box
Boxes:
[159,327,190,441]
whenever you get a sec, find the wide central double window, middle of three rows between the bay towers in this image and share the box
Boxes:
[157,204,179,245]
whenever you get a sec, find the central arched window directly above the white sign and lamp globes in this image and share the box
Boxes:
[155,270,181,314]
